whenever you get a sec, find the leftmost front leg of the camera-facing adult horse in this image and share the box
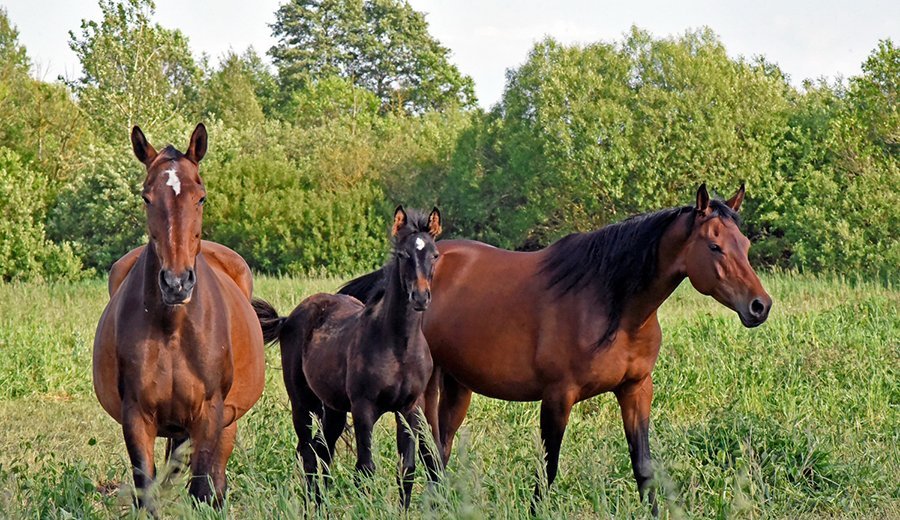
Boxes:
[122,403,157,517]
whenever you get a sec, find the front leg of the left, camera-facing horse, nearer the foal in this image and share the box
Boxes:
[188,399,224,507]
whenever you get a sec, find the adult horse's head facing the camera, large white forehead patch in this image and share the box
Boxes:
[131,123,207,305]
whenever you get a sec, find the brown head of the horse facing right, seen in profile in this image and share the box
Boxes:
[682,184,772,327]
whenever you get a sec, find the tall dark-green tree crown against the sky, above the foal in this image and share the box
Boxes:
[269,0,475,113]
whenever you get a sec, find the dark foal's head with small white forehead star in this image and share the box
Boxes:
[391,206,441,312]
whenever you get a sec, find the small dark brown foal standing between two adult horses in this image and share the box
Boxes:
[254,206,442,508]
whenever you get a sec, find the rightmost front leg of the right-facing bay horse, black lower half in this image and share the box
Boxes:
[615,376,659,516]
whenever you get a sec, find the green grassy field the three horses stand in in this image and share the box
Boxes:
[0,275,900,518]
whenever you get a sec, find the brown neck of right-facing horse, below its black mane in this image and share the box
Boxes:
[622,213,694,329]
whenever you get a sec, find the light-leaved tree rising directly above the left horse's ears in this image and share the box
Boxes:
[69,0,200,142]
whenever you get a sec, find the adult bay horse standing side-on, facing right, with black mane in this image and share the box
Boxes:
[340,185,772,514]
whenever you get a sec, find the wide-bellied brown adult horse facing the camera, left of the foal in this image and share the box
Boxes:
[94,124,265,513]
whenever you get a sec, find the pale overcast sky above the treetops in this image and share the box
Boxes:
[0,0,900,107]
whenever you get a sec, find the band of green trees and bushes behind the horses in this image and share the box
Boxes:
[0,0,900,280]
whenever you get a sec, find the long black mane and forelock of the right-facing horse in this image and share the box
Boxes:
[541,200,740,348]
